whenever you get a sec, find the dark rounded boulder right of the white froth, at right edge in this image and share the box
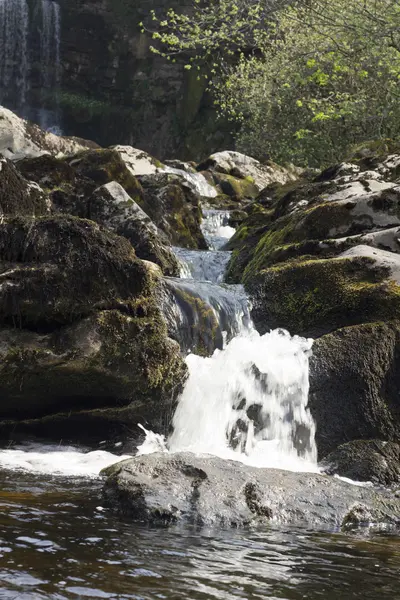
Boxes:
[309,321,400,454]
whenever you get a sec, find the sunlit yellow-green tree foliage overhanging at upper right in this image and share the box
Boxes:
[144,0,400,166]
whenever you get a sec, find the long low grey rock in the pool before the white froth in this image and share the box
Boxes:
[104,453,400,528]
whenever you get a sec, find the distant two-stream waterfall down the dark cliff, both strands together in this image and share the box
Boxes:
[0,0,61,130]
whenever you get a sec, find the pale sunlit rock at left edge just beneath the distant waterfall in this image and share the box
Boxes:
[0,106,98,160]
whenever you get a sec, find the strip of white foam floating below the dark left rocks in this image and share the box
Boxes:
[0,444,130,477]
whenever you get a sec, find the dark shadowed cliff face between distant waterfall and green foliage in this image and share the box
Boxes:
[55,0,230,158]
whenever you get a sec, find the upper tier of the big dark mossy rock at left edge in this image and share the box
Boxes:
[0,216,152,329]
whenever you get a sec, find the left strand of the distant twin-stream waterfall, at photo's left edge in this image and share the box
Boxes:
[0,0,29,108]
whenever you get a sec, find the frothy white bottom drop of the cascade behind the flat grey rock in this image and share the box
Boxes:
[139,330,318,472]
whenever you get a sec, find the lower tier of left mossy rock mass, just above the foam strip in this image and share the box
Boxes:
[0,310,186,439]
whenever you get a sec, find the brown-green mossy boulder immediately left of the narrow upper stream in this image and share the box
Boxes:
[139,173,207,249]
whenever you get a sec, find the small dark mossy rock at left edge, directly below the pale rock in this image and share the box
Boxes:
[0,154,51,216]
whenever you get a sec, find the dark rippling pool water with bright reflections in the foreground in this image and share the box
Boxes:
[0,471,400,600]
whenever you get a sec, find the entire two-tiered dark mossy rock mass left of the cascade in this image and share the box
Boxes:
[0,216,186,439]
